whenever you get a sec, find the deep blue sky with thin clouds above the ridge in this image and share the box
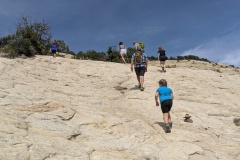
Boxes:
[0,0,240,67]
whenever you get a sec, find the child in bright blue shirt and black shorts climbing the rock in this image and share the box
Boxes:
[155,79,174,133]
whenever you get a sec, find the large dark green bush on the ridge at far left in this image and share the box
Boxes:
[0,17,52,56]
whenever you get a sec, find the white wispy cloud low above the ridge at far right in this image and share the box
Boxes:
[182,28,240,67]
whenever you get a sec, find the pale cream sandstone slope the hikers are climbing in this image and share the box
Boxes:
[0,56,240,160]
